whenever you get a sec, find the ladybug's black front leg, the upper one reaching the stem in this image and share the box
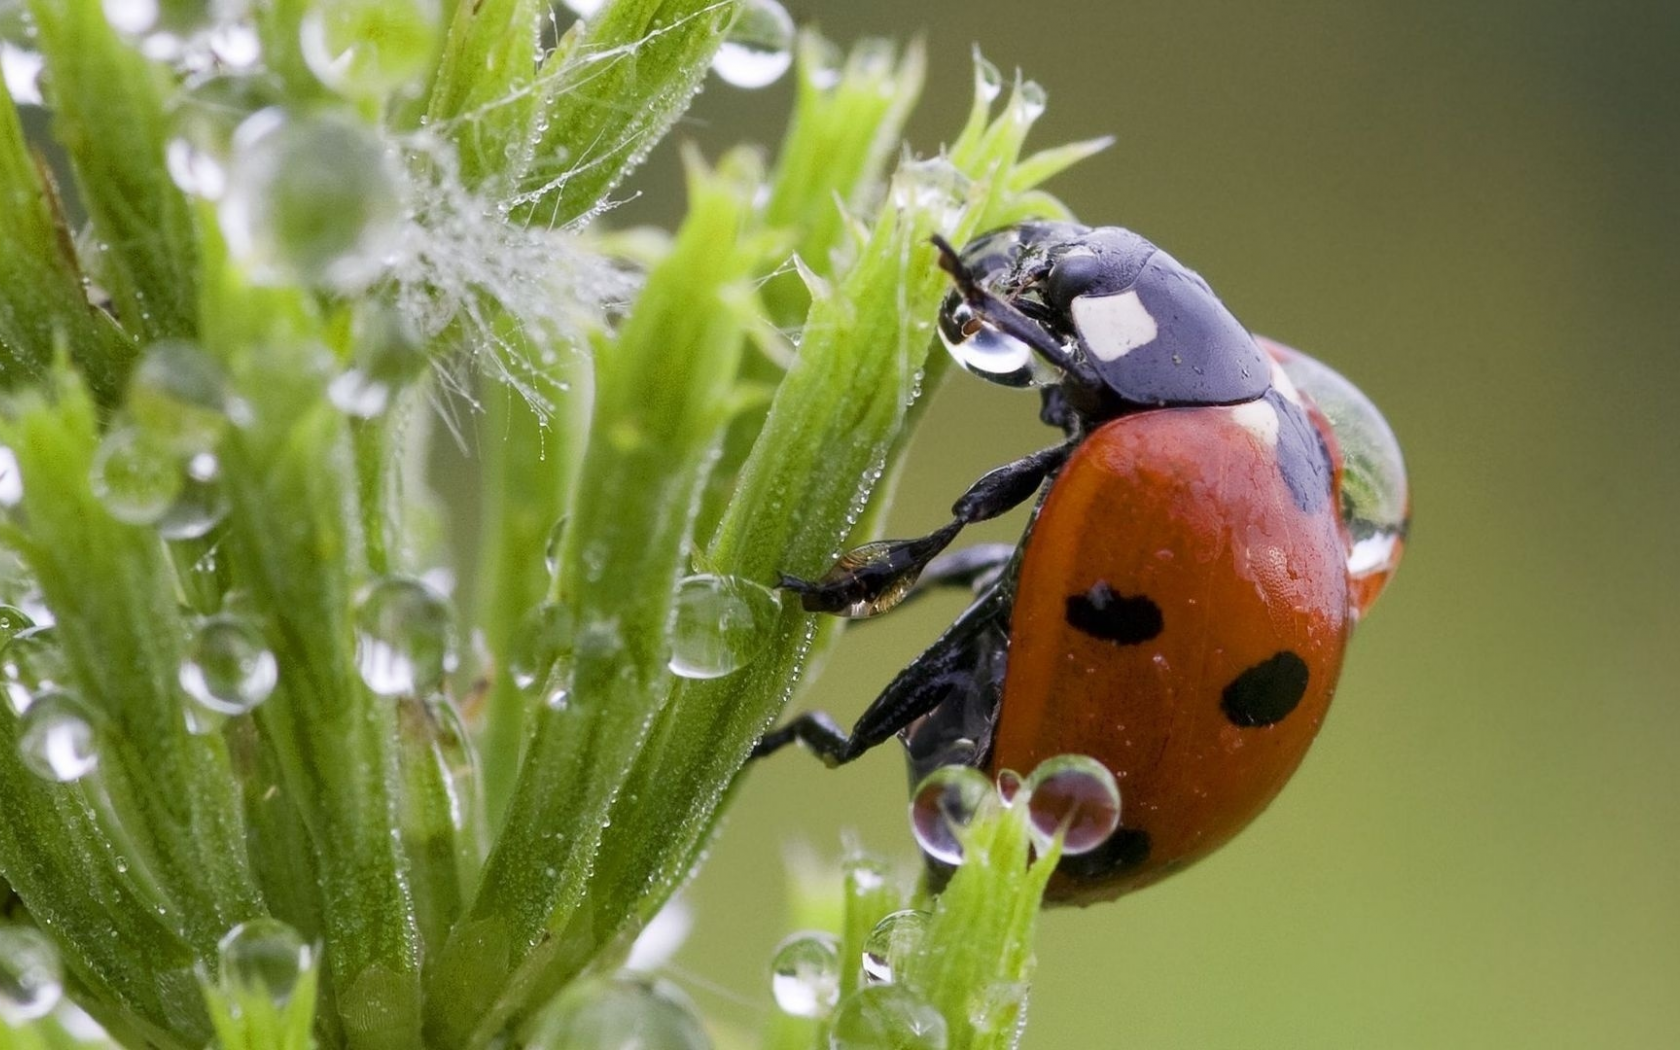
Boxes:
[778,442,1074,617]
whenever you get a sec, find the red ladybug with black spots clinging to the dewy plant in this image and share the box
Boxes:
[754,222,1410,904]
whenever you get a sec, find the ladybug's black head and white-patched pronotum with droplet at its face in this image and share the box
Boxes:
[939,222,1270,415]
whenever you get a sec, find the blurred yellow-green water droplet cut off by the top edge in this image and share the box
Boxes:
[297,0,442,99]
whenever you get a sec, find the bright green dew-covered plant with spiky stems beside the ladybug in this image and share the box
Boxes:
[0,0,1100,1050]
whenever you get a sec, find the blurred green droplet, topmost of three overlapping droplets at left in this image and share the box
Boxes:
[124,339,228,455]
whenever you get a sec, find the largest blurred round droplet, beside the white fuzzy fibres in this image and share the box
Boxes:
[217,109,403,291]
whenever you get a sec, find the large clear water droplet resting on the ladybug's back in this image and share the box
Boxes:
[1258,339,1411,617]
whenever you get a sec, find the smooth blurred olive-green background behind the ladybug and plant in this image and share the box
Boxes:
[627,0,1680,1050]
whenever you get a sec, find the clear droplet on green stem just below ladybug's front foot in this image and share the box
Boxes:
[670,575,781,679]
